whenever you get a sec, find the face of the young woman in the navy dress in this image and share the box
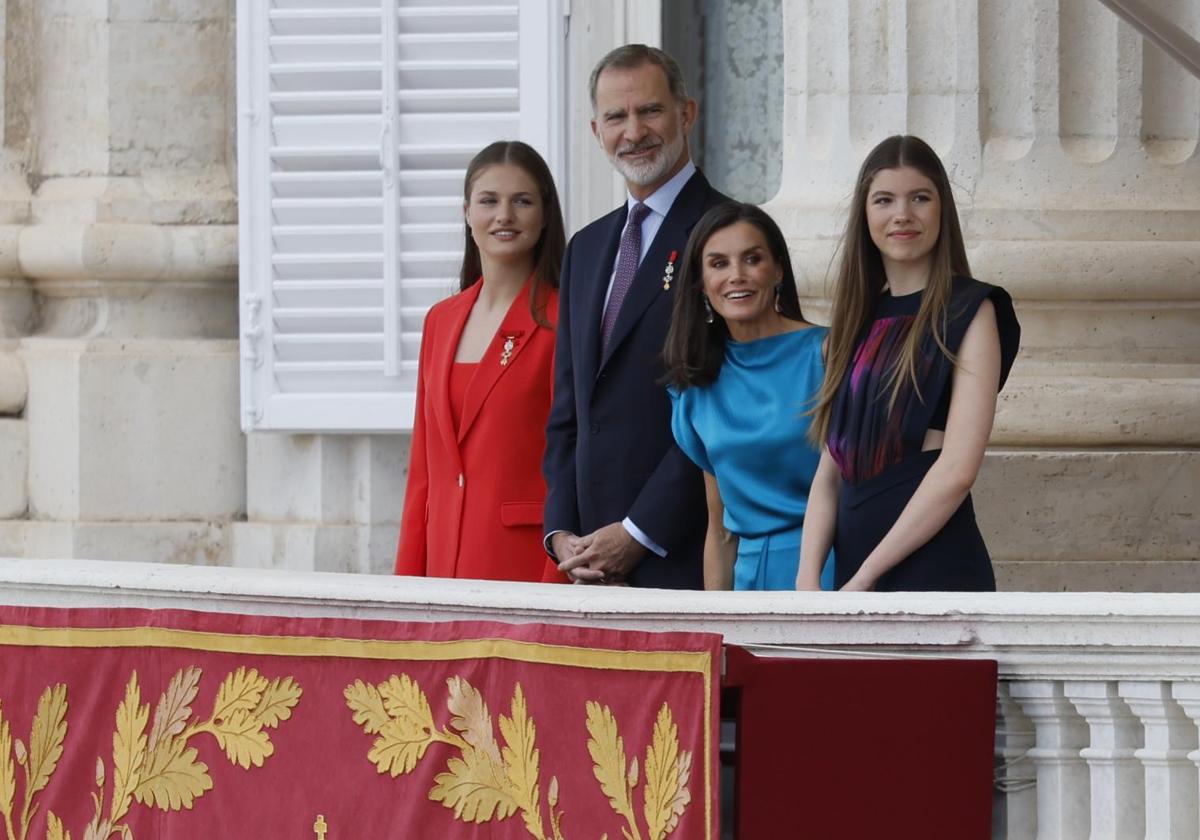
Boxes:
[866,167,942,276]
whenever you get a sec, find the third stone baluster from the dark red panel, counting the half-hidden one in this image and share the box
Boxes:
[1063,682,1146,840]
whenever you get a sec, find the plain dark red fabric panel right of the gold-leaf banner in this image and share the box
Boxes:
[726,647,997,840]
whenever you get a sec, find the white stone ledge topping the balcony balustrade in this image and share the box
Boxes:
[0,559,1200,679]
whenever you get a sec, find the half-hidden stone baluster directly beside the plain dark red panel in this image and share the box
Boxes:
[991,683,1038,840]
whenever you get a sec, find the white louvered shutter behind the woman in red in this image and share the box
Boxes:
[238,0,563,432]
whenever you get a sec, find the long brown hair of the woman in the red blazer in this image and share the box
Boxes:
[458,140,566,326]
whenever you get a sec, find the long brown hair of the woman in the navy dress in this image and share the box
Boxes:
[809,134,971,443]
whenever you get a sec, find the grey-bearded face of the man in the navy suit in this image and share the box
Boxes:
[592,62,696,194]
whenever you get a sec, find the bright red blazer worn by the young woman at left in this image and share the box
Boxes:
[396,282,566,581]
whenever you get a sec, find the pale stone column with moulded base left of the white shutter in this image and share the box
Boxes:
[0,0,245,563]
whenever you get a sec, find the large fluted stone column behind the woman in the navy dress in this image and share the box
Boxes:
[769,0,1200,590]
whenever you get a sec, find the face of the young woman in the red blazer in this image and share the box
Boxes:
[464,163,545,262]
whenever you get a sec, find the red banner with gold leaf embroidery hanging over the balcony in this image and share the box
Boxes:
[0,607,720,840]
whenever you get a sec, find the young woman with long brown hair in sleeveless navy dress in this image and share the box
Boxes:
[796,136,1020,590]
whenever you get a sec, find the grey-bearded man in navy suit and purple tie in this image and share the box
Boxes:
[542,44,728,589]
